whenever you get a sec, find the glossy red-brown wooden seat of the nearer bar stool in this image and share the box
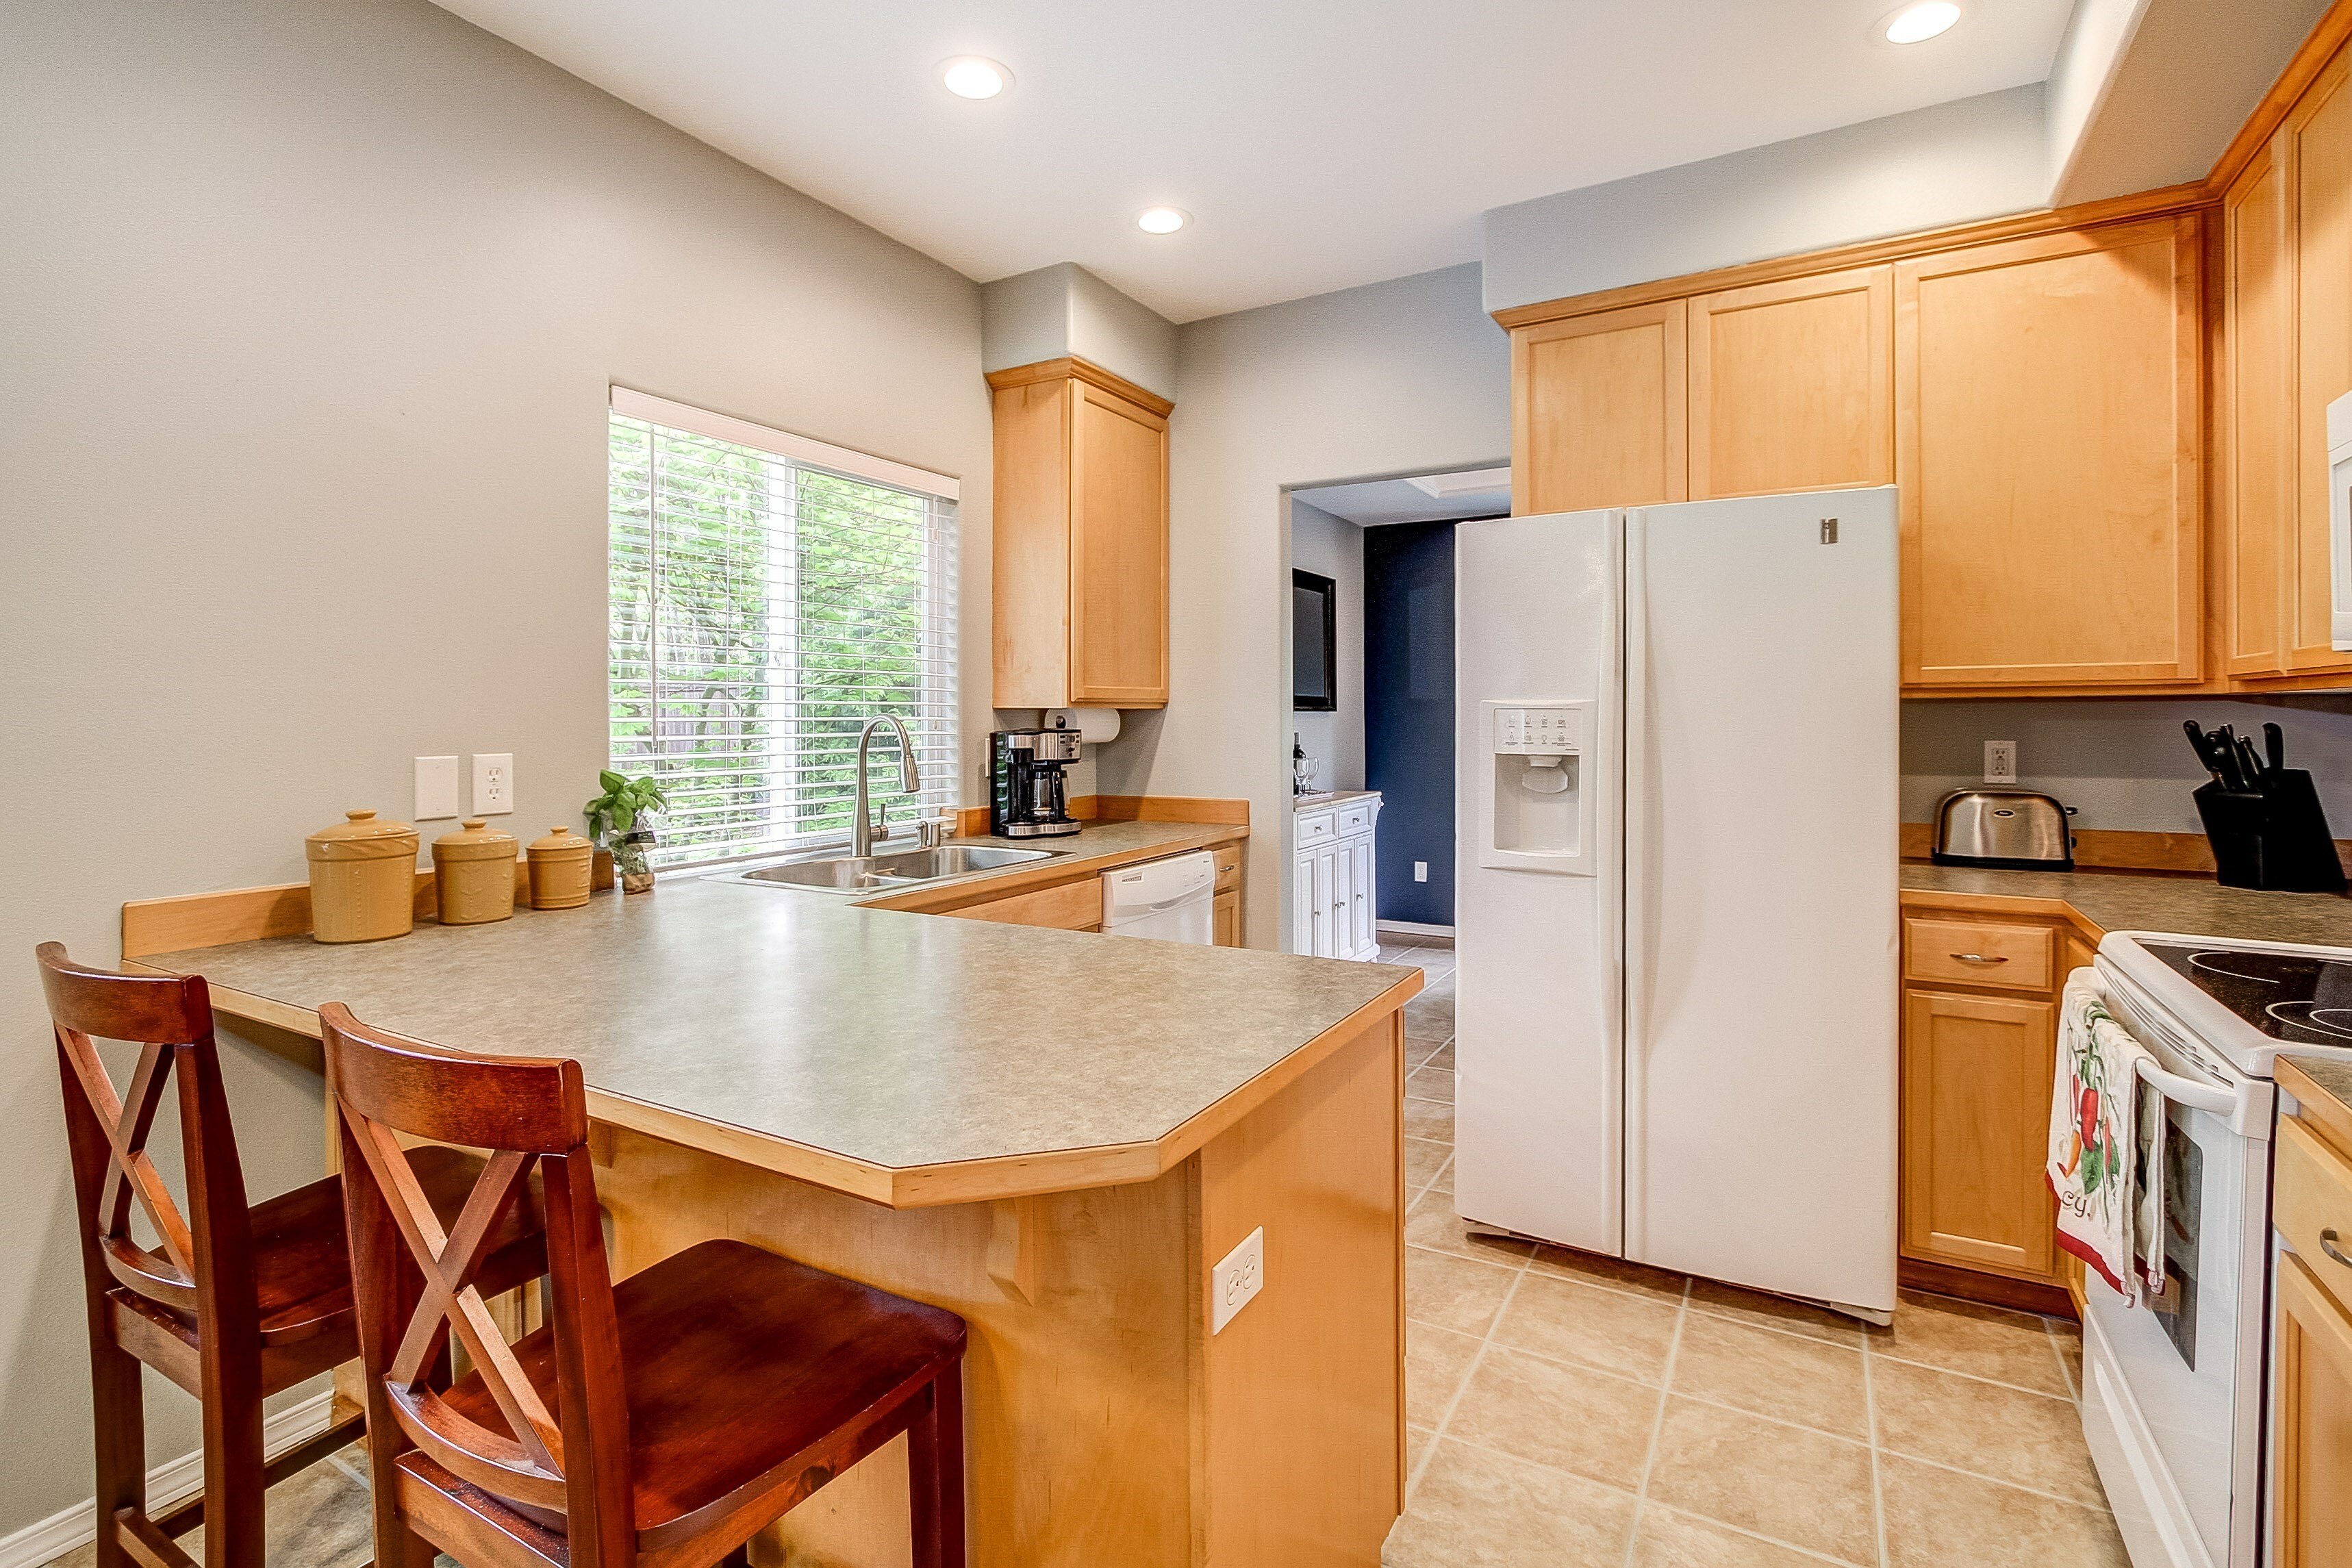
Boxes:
[433,1241,964,1533]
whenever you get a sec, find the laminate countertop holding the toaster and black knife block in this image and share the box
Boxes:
[1900,861,2352,948]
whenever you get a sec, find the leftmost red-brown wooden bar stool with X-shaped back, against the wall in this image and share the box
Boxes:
[36,943,546,1568]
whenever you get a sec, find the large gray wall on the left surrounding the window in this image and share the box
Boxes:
[0,0,992,1535]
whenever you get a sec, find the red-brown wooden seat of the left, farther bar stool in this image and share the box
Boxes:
[151,1145,546,1358]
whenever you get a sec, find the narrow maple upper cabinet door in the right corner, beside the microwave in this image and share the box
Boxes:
[2221,148,2296,674]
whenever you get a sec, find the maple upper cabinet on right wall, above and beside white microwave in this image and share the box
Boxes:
[2218,54,2352,679]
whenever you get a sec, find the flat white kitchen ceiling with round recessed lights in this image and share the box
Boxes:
[440,0,2072,322]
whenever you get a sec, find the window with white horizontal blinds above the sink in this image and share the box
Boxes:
[611,388,957,865]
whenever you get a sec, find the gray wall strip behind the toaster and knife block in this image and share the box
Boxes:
[1903,696,2352,839]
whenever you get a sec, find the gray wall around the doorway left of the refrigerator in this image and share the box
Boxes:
[1096,264,1510,948]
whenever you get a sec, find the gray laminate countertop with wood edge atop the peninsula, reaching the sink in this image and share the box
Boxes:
[134,823,1421,1209]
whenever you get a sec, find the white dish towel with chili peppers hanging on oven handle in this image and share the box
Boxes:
[2049,969,2166,1304]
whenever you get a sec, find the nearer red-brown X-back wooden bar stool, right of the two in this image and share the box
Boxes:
[320,1002,964,1568]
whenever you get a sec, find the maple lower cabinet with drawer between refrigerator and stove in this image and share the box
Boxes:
[1900,905,2072,1286]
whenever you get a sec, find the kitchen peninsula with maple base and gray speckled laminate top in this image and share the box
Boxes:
[129,877,1421,1568]
